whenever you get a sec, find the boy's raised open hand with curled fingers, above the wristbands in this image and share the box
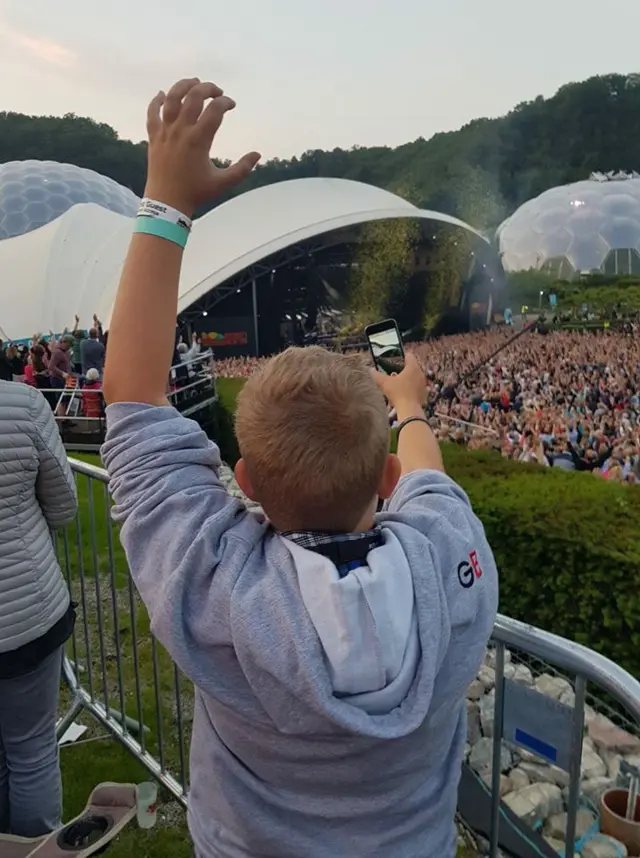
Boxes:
[145,78,260,217]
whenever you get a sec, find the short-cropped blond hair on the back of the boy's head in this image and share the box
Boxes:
[236,346,389,532]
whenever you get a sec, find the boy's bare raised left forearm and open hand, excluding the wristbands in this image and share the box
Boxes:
[103,78,260,405]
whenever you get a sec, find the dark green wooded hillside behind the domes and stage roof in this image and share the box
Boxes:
[0,74,640,233]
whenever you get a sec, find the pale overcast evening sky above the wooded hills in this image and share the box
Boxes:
[0,0,640,158]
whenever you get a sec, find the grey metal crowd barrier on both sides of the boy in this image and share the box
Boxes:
[56,460,640,858]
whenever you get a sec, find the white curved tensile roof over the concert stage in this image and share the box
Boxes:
[0,179,484,339]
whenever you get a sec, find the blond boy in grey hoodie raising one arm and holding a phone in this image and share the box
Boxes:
[103,80,498,858]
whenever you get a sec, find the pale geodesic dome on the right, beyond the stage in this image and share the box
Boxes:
[497,178,640,276]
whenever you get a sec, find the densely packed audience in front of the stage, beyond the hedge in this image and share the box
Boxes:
[216,329,640,483]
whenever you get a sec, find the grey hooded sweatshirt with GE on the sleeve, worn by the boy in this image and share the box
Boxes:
[103,404,498,858]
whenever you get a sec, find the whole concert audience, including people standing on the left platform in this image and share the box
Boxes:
[0,316,640,483]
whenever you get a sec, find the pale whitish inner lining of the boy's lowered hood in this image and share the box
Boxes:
[282,528,420,715]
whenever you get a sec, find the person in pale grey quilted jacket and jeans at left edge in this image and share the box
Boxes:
[0,381,77,837]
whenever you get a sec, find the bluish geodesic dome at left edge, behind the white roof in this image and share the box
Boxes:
[0,161,140,240]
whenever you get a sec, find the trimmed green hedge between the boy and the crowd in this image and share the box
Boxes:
[214,379,640,675]
